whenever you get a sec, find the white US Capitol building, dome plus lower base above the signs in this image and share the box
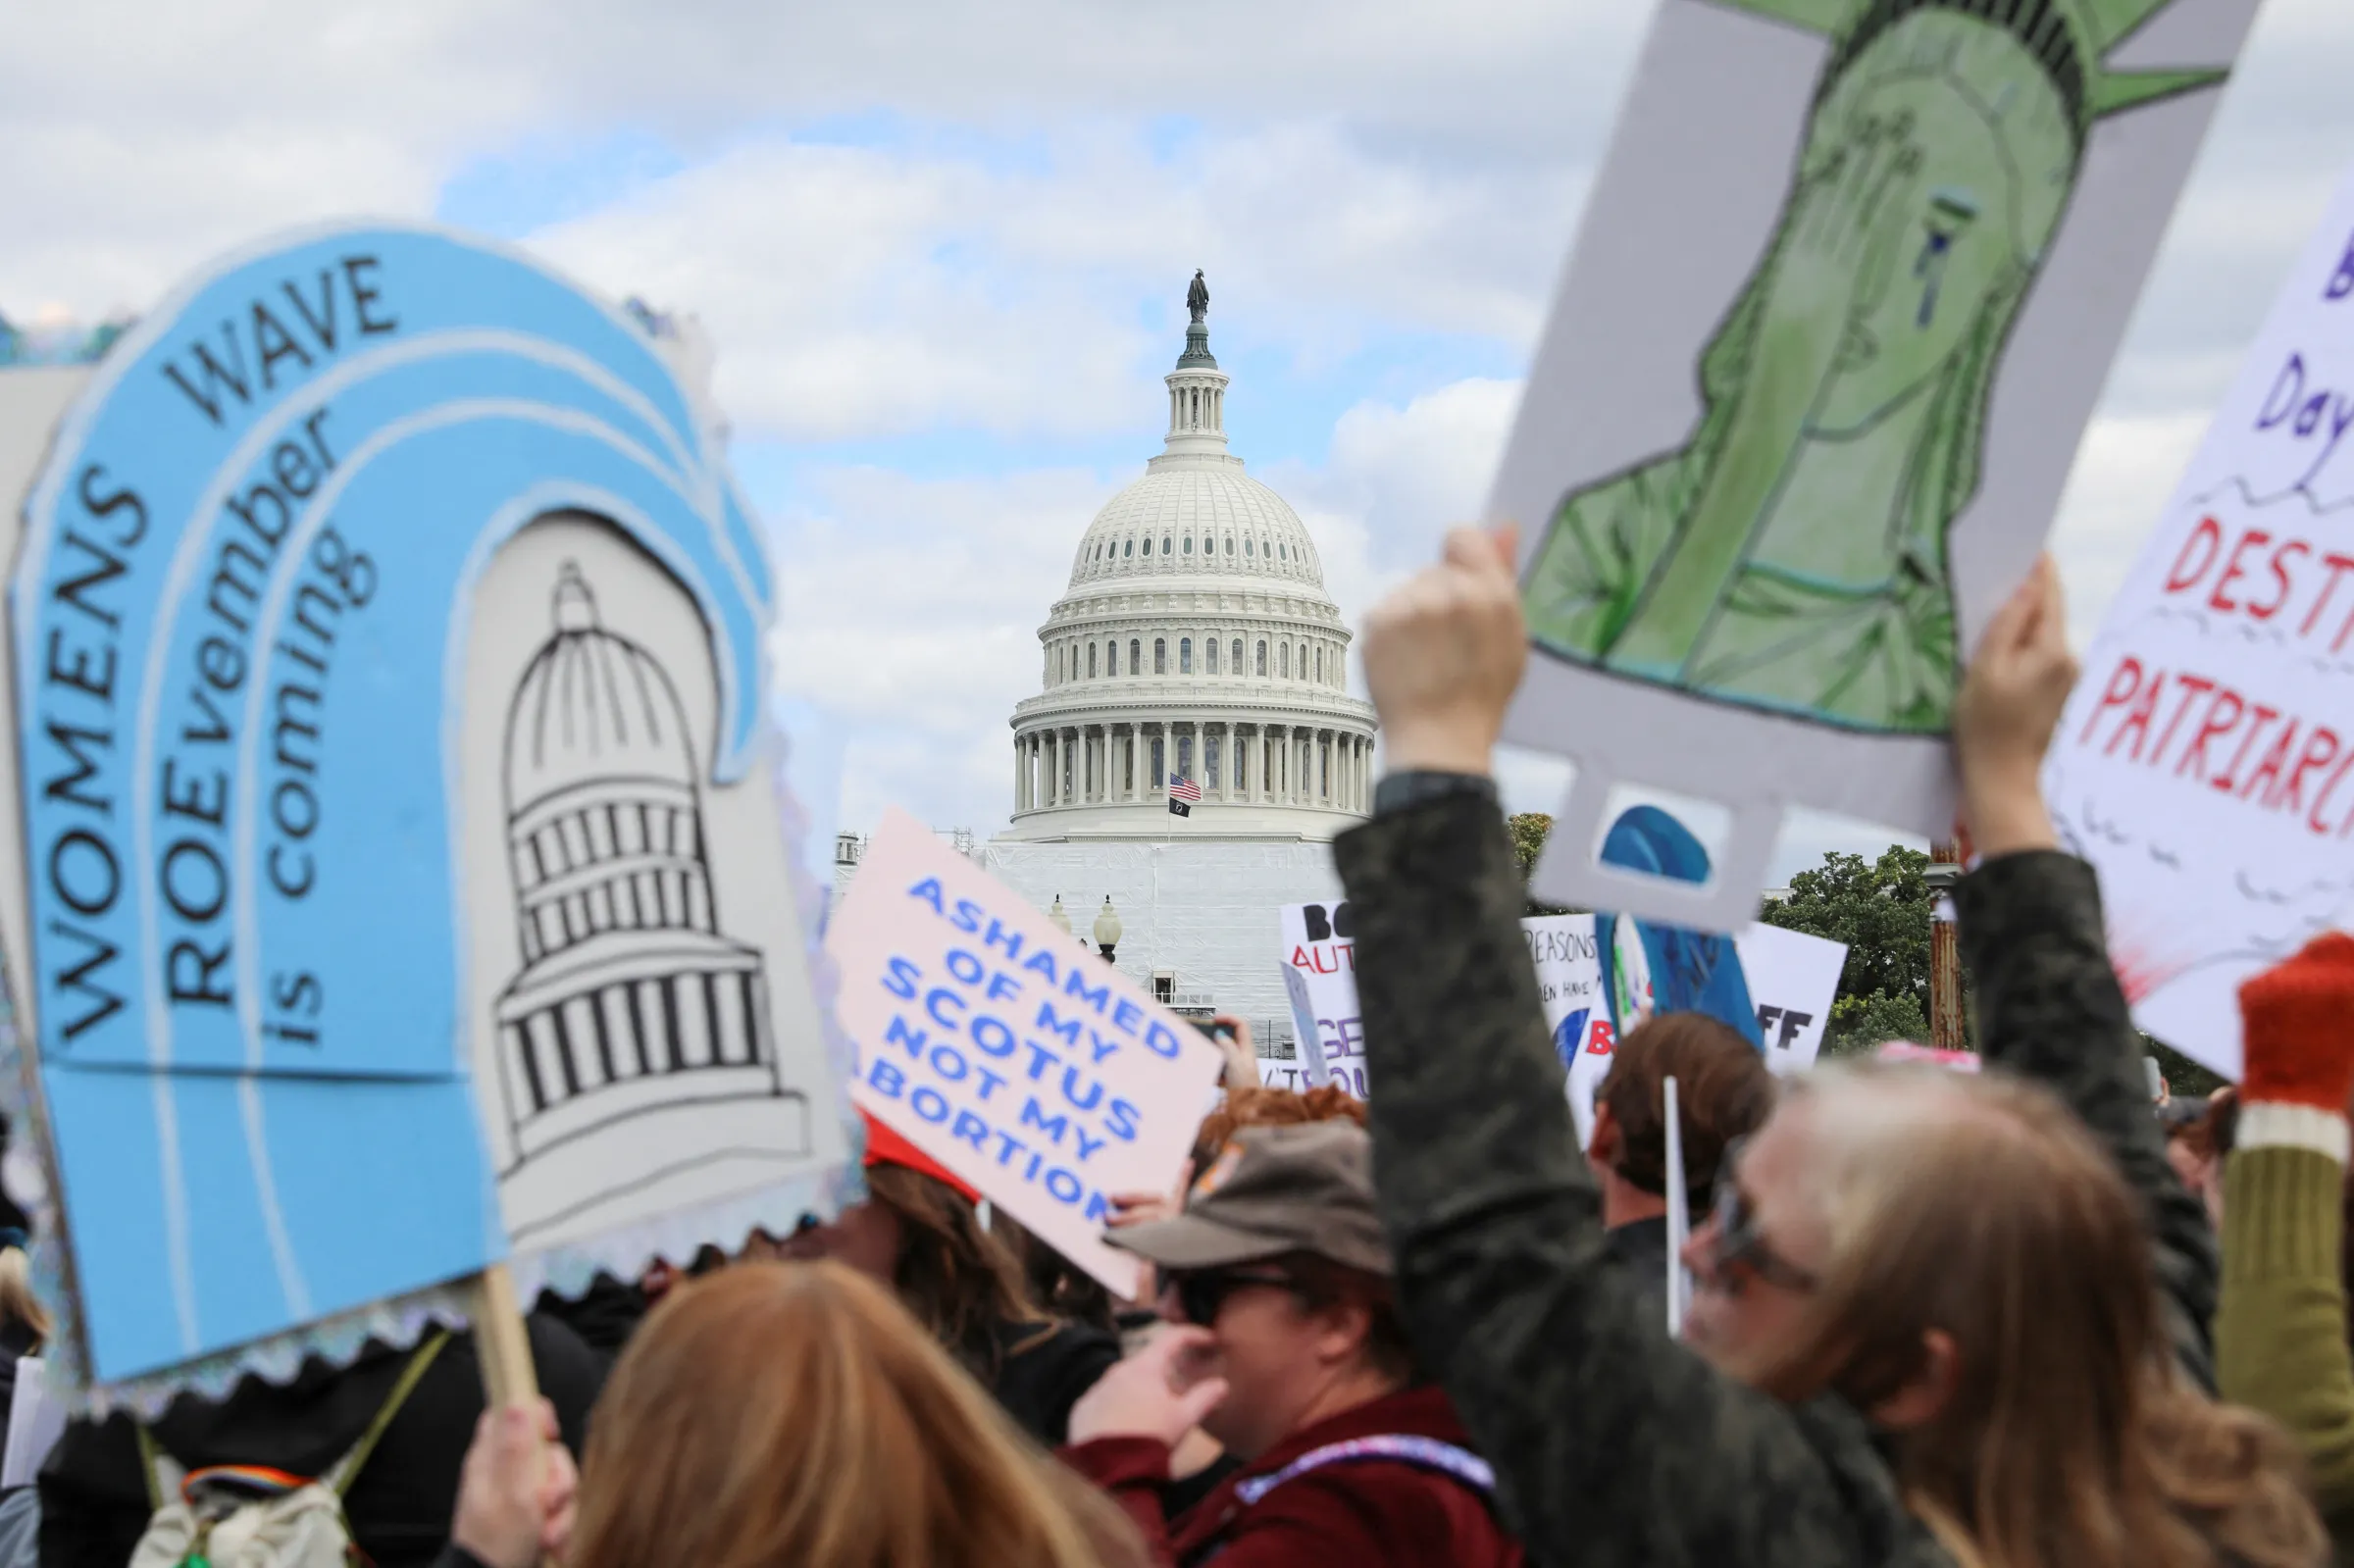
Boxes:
[950,274,1375,1043]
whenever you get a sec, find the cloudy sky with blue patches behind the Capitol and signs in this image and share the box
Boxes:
[0,0,2354,876]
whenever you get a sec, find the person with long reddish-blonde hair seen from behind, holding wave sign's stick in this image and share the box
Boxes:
[449,1262,1144,1568]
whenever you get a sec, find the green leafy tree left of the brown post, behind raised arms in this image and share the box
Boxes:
[1759,843,1930,1052]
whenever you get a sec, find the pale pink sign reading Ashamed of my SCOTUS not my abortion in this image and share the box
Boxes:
[826,810,1224,1297]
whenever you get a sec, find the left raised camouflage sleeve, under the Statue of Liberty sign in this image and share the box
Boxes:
[1335,796,1902,1568]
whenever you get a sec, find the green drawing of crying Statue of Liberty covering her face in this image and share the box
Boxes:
[1525,0,2225,733]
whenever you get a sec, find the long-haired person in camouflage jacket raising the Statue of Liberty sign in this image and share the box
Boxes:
[1335,530,2328,1568]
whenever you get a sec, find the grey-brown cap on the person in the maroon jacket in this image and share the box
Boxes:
[1104,1121,1391,1279]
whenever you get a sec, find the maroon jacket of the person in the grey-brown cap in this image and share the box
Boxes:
[1061,1387,1525,1568]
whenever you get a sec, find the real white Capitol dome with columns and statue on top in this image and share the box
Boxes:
[1005,289,1375,840]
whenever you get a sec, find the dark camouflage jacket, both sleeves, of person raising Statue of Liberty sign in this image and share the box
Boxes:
[1335,796,2215,1568]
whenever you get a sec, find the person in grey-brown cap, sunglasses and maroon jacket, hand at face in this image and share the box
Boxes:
[1064,1121,1523,1568]
